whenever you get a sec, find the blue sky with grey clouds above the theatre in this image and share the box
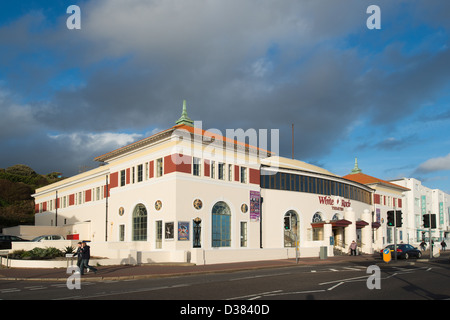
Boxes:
[0,0,450,193]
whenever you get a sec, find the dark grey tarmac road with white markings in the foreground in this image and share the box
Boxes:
[0,261,450,304]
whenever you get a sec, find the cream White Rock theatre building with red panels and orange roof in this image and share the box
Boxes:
[26,106,378,264]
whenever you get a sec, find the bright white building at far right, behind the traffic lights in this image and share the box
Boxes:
[392,178,450,243]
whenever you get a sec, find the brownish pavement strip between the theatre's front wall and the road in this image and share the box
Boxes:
[0,251,450,281]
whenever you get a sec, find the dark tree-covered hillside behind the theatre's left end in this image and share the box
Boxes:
[0,164,64,229]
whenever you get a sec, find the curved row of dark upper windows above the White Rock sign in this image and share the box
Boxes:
[261,169,372,204]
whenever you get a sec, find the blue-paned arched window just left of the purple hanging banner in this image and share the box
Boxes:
[212,201,231,247]
